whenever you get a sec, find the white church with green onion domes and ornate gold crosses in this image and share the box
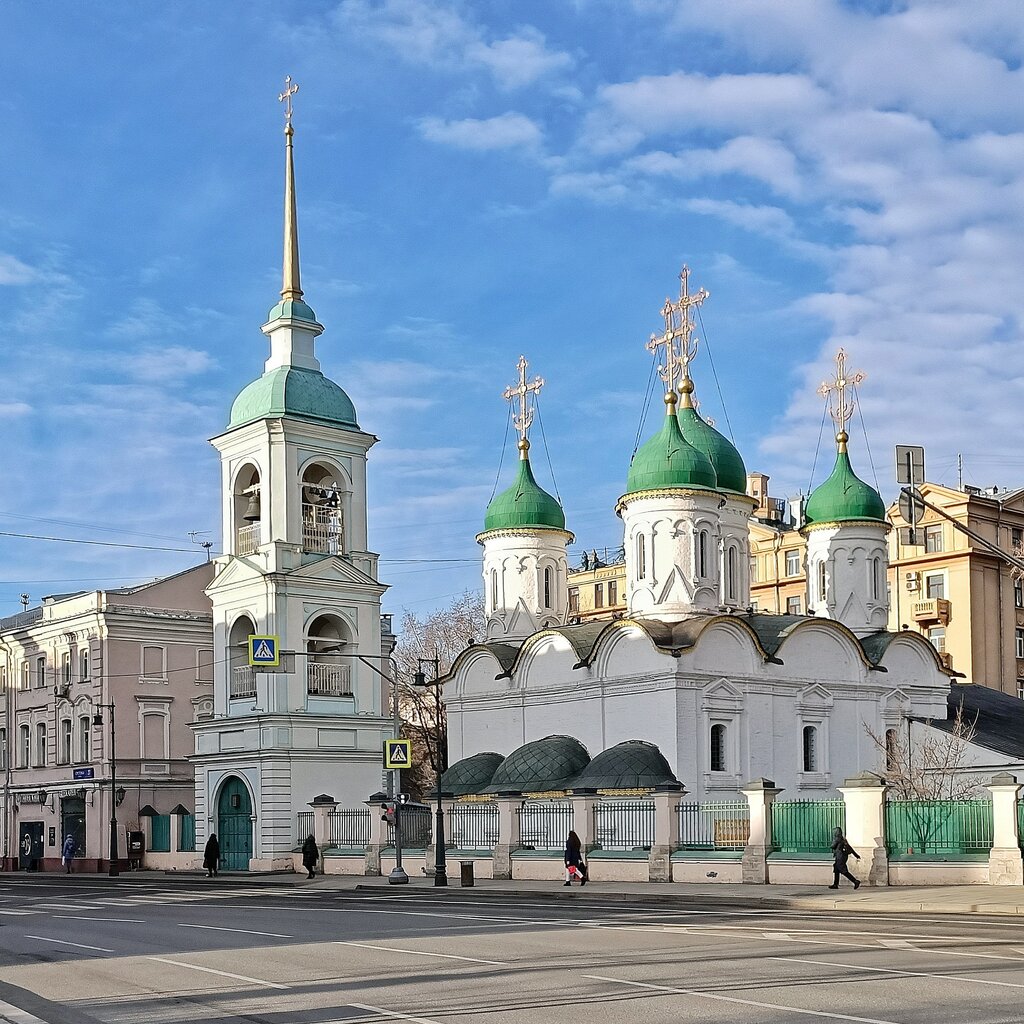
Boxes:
[442,267,950,799]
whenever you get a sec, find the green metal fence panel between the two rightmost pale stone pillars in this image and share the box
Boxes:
[886,800,991,856]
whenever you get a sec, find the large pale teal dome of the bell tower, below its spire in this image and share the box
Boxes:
[228,367,358,429]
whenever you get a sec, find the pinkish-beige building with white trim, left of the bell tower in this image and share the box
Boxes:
[0,564,213,870]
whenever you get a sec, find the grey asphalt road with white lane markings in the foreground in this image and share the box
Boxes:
[0,876,1024,1024]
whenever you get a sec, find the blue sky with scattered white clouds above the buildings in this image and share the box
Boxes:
[0,0,1024,615]
